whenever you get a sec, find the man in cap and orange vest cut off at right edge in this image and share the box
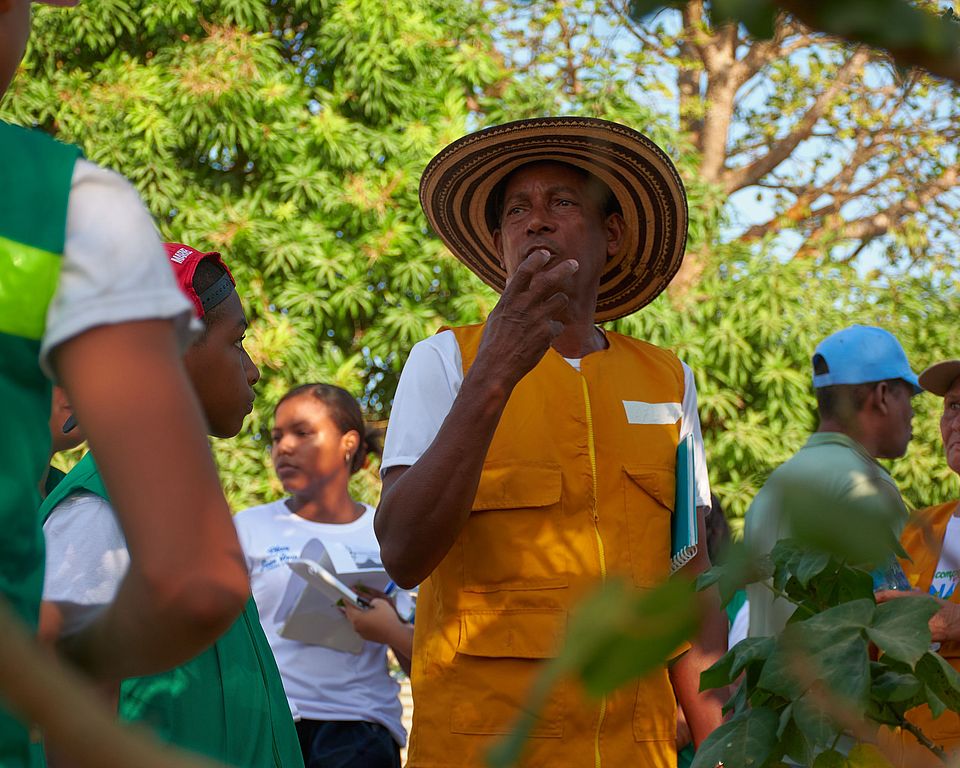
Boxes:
[877,360,960,768]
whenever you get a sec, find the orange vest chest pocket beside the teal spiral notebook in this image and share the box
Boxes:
[622,465,677,587]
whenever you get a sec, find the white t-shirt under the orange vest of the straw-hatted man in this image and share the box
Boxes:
[380,331,710,507]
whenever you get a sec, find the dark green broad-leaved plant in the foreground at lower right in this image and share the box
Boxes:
[693,487,960,768]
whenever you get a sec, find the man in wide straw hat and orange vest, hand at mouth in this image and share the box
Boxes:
[376,117,725,768]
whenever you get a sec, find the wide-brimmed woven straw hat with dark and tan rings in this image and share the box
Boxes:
[420,117,687,322]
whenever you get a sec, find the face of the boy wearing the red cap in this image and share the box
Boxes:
[183,293,260,437]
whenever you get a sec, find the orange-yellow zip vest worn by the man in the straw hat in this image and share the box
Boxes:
[407,325,683,768]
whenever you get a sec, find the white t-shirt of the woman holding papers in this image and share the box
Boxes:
[234,499,407,746]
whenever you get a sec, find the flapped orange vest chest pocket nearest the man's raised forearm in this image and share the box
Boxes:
[459,462,571,592]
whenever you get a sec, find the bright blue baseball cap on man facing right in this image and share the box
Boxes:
[813,325,923,394]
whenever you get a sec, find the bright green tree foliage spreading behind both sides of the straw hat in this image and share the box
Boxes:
[9,0,957,516]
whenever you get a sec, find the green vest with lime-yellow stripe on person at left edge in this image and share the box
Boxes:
[0,122,80,768]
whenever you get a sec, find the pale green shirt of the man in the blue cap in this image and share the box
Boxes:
[744,432,907,637]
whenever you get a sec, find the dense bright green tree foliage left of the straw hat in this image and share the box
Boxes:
[4,0,510,505]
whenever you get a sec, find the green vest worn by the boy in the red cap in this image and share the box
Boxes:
[41,453,303,768]
